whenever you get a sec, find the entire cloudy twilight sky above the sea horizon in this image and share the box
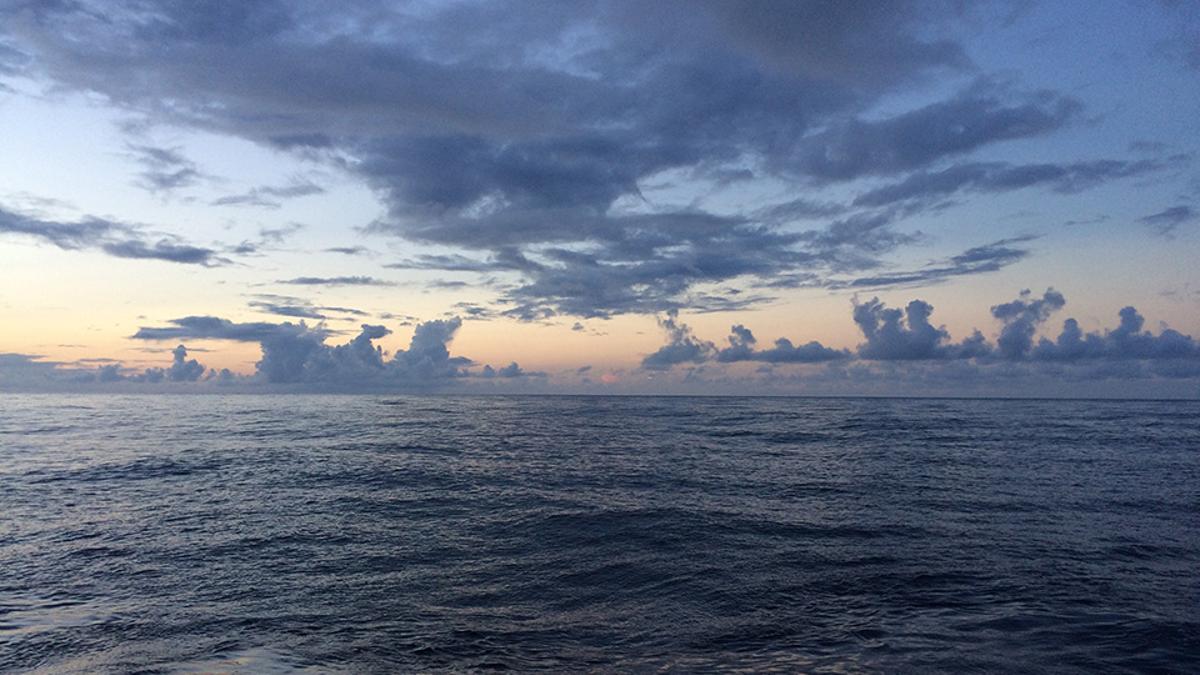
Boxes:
[0,0,1200,398]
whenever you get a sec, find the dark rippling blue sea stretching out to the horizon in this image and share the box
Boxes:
[0,395,1200,673]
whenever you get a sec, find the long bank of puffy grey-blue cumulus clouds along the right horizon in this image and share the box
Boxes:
[643,288,1200,395]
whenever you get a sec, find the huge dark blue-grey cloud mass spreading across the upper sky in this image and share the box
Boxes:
[0,0,1099,312]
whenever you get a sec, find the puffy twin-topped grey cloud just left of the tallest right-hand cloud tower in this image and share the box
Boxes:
[854,298,991,360]
